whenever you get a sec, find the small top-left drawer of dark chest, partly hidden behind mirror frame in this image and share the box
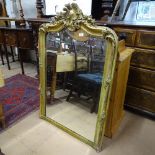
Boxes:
[114,28,136,46]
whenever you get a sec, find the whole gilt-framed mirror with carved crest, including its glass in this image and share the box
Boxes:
[39,3,118,151]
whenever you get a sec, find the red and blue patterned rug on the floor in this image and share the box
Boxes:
[0,74,39,131]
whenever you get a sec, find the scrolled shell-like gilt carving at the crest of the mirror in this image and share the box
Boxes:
[54,3,95,31]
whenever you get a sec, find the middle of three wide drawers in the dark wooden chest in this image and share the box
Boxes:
[128,67,155,91]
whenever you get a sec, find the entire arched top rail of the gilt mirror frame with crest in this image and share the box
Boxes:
[40,3,117,43]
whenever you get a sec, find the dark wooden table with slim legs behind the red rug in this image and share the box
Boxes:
[0,26,35,74]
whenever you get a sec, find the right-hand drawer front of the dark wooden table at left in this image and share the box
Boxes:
[18,31,33,49]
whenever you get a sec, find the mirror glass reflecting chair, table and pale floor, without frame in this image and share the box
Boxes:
[46,30,105,141]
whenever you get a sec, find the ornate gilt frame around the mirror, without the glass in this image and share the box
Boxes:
[39,3,118,151]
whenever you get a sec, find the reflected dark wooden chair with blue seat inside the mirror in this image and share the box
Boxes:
[67,40,103,113]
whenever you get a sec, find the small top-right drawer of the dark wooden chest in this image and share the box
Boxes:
[136,31,155,49]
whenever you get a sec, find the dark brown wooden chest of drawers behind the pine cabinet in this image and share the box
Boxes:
[97,23,155,119]
